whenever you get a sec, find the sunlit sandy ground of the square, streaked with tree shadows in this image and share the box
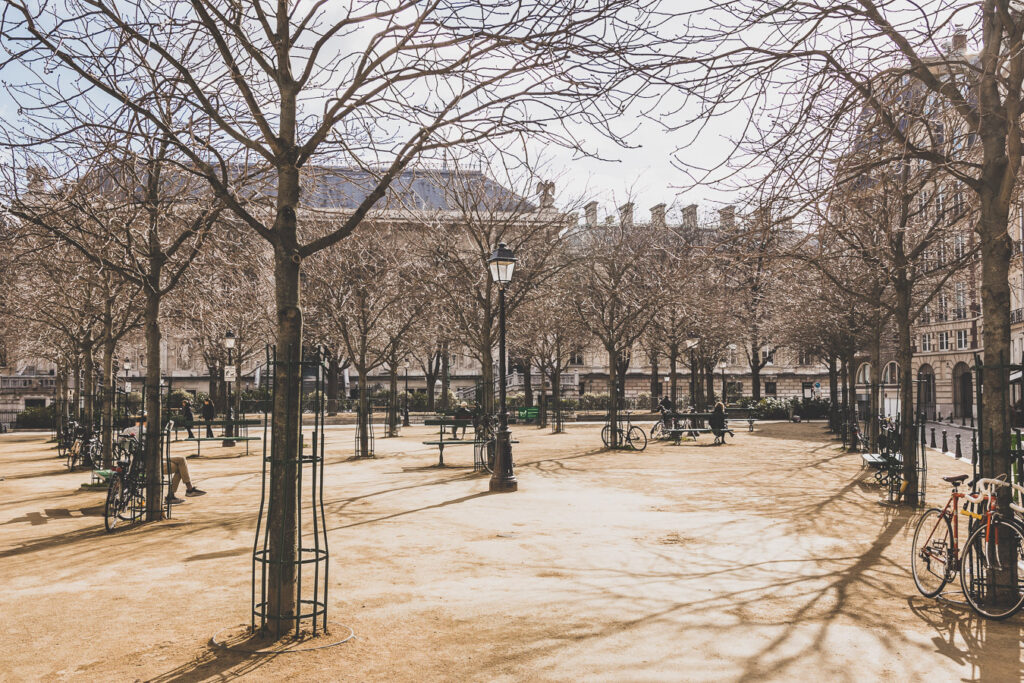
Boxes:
[0,424,1024,681]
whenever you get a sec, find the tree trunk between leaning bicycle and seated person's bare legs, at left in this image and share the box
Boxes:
[143,290,164,521]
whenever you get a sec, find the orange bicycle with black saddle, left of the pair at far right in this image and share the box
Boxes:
[910,474,988,598]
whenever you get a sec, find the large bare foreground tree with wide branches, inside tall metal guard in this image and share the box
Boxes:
[0,0,655,634]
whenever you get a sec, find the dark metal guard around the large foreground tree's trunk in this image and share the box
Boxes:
[250,346,330,637]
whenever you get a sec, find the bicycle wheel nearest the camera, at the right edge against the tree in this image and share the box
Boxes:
[961,519,1024,620]
